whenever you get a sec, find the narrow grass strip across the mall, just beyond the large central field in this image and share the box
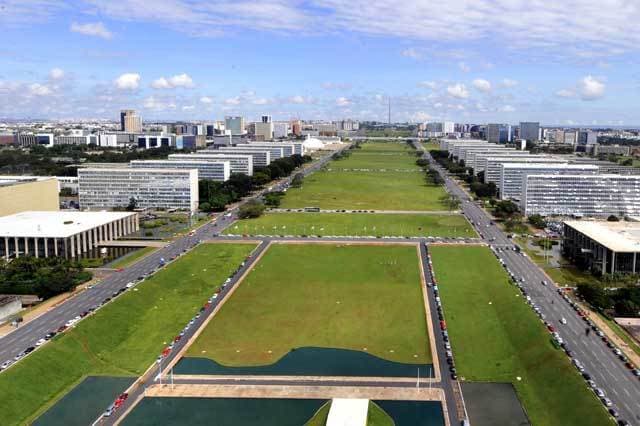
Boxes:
[224,213,477,238]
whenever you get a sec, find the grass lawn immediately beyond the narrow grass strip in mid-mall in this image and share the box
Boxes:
[280,169,446,211]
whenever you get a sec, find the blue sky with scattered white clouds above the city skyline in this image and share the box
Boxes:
[0,0,640,125]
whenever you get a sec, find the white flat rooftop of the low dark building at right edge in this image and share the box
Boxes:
[564,220,640,253]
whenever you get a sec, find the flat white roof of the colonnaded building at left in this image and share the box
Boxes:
[0,211,136,238]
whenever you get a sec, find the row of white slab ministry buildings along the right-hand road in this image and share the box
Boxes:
[440,139,640,217]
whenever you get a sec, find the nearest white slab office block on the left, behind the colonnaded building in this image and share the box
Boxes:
[78,168,198,211]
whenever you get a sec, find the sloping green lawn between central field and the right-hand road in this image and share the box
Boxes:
[430,246,611,426]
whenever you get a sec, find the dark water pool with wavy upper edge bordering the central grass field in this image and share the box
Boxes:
[173,347,433,377]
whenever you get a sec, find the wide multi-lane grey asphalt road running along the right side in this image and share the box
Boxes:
[418,142,640,425]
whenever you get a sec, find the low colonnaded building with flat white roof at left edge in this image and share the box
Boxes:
[0,211,139,259]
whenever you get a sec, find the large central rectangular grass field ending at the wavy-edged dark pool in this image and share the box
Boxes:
[187,244,431,366]
